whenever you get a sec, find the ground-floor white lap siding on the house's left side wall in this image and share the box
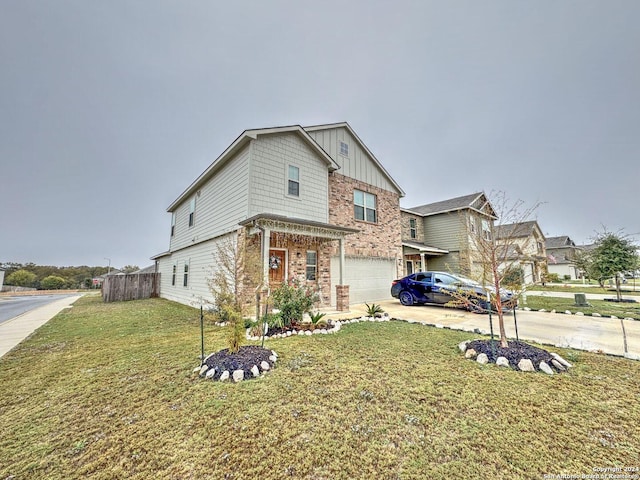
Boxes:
[158,231,237,307]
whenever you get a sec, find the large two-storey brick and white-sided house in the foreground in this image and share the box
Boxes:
[152,123,404,310]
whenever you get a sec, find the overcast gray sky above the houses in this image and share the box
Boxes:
[0,0,640,267]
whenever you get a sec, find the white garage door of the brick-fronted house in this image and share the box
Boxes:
[331,257,397,305]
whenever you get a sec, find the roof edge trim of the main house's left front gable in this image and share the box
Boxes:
[167,125,340,212]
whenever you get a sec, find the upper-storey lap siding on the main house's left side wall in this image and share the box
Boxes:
[170,146,250,251]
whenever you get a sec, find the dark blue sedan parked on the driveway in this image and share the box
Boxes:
[391,272,514,312]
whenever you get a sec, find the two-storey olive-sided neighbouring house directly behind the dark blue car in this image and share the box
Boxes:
[401,192,497,277]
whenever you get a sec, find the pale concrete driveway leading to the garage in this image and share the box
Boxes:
[327,299,640,360]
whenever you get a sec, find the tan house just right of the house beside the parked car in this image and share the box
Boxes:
[494,220,547,285]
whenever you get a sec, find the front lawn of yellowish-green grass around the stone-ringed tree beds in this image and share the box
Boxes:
[0,297,640,480]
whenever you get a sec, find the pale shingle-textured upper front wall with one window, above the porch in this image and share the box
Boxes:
[248,133,329,223]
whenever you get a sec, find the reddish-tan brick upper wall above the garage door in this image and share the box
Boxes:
[329,172,408,274]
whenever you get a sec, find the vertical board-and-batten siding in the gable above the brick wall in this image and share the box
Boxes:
[309,127,396,192]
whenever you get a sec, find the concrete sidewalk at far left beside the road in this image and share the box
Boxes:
[0,295,82,358]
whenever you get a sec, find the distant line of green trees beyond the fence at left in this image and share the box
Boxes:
[0,262,138,290]
